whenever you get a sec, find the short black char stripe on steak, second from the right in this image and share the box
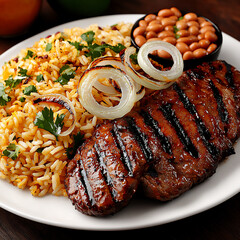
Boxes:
[209,80,228,123]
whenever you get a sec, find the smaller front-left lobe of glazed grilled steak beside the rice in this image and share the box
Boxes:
[65,118,150,216]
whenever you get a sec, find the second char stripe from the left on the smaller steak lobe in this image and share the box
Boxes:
[94,143,117,200]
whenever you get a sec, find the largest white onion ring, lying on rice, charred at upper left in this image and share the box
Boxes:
[78,66,136,119]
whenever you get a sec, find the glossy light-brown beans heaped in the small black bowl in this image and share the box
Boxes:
[133,7,218,60]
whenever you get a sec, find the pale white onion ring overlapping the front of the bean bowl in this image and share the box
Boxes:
[137,40,183,82]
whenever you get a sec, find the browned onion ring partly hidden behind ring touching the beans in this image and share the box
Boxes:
[121,47,173,90]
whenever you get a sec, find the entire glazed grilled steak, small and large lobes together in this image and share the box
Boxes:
[65,61,240,216]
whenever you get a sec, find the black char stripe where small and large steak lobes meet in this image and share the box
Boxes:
[126,117,153,162]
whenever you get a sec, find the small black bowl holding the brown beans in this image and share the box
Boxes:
[131,11,223,70]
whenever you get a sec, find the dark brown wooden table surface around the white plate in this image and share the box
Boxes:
[0,0,240,240]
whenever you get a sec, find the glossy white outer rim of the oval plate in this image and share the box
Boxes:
[0,14,240,231]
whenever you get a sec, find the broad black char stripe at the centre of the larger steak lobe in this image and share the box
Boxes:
[159,103,199,158]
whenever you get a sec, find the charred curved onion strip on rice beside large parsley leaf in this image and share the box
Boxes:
[33,93,77,136]
